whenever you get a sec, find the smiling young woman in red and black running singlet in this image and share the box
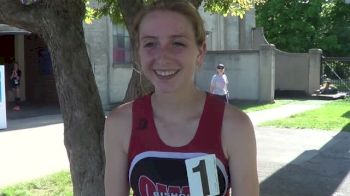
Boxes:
[104,0,259,196]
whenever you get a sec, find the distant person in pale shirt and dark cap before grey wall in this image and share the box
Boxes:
[210,63,228,102]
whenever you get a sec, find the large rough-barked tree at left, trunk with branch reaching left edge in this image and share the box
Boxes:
[0,0,105,196]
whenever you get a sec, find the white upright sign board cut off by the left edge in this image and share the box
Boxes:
[0,65,7,129]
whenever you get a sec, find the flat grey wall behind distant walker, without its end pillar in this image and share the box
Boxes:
[195,50,259,100]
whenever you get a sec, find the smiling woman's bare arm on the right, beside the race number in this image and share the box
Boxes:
[222,105,259,196]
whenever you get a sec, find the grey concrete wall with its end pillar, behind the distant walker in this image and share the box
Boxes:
[195,45,275,102]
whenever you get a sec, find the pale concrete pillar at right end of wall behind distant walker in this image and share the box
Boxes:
[258,44,275,102]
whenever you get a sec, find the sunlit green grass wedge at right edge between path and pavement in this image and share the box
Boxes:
[259,99,350,132]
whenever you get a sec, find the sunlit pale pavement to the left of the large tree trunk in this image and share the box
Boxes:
[0,115,69,188]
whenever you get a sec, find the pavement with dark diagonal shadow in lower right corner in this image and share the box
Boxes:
[256,127,350,196]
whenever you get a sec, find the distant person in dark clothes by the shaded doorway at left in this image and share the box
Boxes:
[10,62,22,111]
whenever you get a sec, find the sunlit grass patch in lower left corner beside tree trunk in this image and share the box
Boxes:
[0,171,73,196]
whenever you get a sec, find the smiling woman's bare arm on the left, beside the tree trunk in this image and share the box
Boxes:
[104,105,131,196]
